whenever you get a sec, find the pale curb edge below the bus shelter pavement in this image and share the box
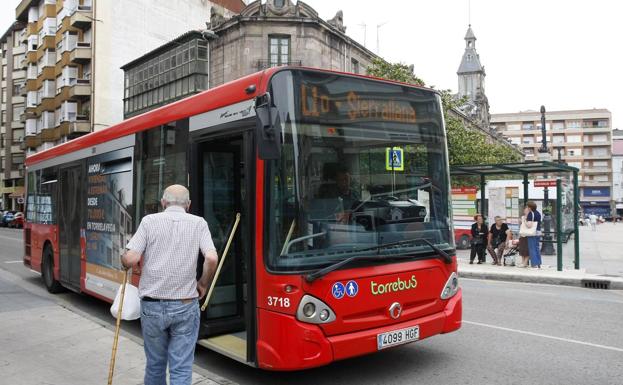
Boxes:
[458,268,623,290]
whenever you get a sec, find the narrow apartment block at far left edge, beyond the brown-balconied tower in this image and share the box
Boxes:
[0,22,26,210]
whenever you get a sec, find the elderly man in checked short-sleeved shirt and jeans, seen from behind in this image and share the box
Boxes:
[121,185,218,385]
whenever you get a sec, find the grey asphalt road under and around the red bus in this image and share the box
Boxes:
[0,229,623,385]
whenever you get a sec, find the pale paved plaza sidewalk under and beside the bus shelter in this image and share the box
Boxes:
[457,223,623,290]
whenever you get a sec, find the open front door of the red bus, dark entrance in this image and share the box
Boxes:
[191,136,251,362]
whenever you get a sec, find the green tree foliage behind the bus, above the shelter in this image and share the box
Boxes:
[368,59,521,185]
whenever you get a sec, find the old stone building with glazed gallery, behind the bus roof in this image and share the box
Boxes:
[122,0,377,117]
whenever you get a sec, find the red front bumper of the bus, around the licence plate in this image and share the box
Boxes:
[257,290,462,370]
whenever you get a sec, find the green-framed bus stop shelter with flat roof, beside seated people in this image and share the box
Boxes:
[450,161,580,271]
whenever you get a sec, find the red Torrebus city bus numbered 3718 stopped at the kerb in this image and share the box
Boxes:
[24,67,462,370]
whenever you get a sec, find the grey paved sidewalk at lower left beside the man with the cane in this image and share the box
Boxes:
[0,270,224,385]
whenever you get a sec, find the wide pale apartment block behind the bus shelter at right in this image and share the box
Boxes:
[491,109,613,216]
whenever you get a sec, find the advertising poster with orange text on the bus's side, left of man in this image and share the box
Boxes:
[84,149,132,299]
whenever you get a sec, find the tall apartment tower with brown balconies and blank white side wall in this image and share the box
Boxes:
[14,0,244,155]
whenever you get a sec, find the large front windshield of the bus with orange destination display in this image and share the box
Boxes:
[266,70,454,272]
